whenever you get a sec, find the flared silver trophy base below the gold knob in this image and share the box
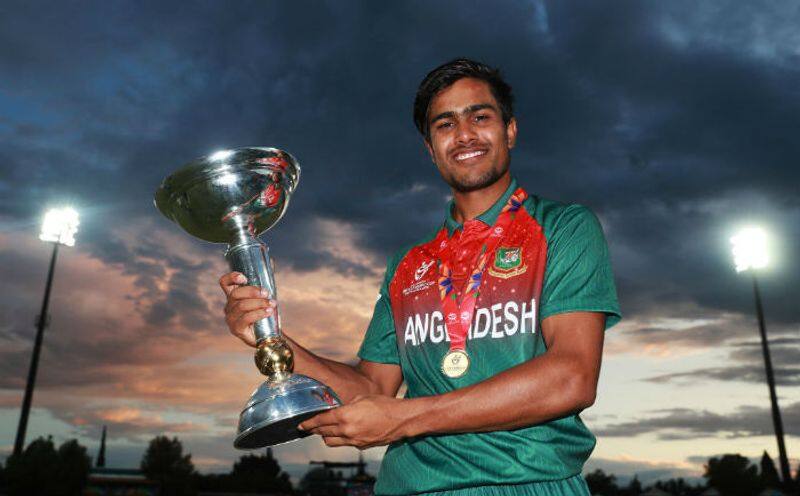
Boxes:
[233,374,342,450]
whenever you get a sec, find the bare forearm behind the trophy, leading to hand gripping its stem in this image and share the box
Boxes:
[283,334,381,403]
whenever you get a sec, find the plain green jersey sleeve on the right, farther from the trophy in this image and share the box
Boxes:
[540,205,622,329]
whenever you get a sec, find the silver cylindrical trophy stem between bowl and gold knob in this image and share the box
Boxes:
[225,236,281,344]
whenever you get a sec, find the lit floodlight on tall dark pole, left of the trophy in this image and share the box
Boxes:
[14,207,78,455]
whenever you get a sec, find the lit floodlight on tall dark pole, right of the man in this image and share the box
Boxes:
[731,227,792,486]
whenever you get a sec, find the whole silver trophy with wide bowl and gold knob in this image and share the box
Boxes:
[155,148,341,449]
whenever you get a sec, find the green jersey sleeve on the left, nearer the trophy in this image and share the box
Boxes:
[358,255,400,365]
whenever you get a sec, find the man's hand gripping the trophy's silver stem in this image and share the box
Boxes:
[219,272,276,347]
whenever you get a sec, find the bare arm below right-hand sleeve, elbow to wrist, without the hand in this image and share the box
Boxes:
[402,312,605,436]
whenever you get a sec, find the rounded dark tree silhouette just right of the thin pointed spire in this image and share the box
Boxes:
[141,436,194,496]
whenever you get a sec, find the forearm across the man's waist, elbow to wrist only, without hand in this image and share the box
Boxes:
[401,353,597,437]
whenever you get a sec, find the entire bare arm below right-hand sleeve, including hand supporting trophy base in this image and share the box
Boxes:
[302,312,605,448]
